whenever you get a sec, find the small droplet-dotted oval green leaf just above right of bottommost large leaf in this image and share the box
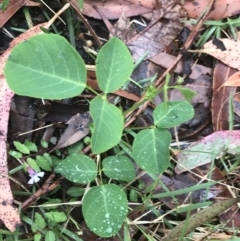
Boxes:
[102,155,136,182]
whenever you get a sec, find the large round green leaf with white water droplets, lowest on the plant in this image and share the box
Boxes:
[82,184,128,237]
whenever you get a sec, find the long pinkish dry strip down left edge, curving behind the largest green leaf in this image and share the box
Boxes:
[0,4,70,232]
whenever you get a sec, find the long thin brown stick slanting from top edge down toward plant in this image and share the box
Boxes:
[124,0,215,127]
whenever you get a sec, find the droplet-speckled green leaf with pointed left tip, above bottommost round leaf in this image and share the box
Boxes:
[55,153,97,183]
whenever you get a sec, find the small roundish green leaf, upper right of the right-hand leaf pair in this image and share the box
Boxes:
[153,100,194,128]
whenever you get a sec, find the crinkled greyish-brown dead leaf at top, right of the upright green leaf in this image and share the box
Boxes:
[127,0,187,60]
